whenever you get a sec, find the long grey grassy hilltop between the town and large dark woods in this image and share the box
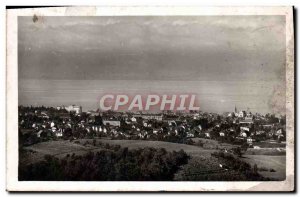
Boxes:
[20,139,213,164]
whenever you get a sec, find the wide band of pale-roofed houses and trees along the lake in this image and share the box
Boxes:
[19,106,285,144]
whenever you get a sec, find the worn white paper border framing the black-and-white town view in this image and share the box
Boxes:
[6,6,295,191]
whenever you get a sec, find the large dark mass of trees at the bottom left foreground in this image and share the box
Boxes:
[19,144,189,181]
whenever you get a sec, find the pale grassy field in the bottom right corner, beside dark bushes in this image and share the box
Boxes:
[243,155,286,180]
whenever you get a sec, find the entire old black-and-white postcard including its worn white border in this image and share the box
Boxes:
[6,7,295,191]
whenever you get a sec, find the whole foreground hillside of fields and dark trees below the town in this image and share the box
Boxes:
[19,139,285,181]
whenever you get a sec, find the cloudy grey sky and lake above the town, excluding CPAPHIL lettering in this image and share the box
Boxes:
[18,16,286,113]
